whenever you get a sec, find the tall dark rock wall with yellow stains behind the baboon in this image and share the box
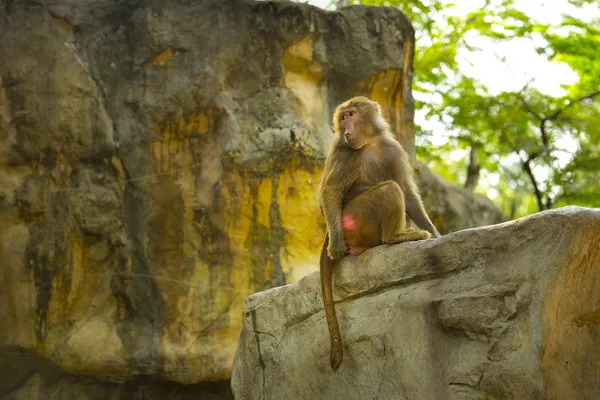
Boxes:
[0,0,422,399]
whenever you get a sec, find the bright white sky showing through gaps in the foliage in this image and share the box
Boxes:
[303,0,600,199]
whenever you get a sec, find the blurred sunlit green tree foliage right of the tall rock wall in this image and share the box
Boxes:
[332,0,600,217]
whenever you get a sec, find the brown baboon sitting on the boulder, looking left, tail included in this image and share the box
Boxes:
[319,97,440,371]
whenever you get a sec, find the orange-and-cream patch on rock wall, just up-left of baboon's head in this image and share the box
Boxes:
[283,36,325,124]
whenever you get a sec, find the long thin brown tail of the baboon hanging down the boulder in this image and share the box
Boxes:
[320,234,344,371]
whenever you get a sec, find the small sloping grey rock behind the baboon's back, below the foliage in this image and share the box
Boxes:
[415,162,509,234]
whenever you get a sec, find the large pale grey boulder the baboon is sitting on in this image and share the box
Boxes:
[232,207,600,400]
